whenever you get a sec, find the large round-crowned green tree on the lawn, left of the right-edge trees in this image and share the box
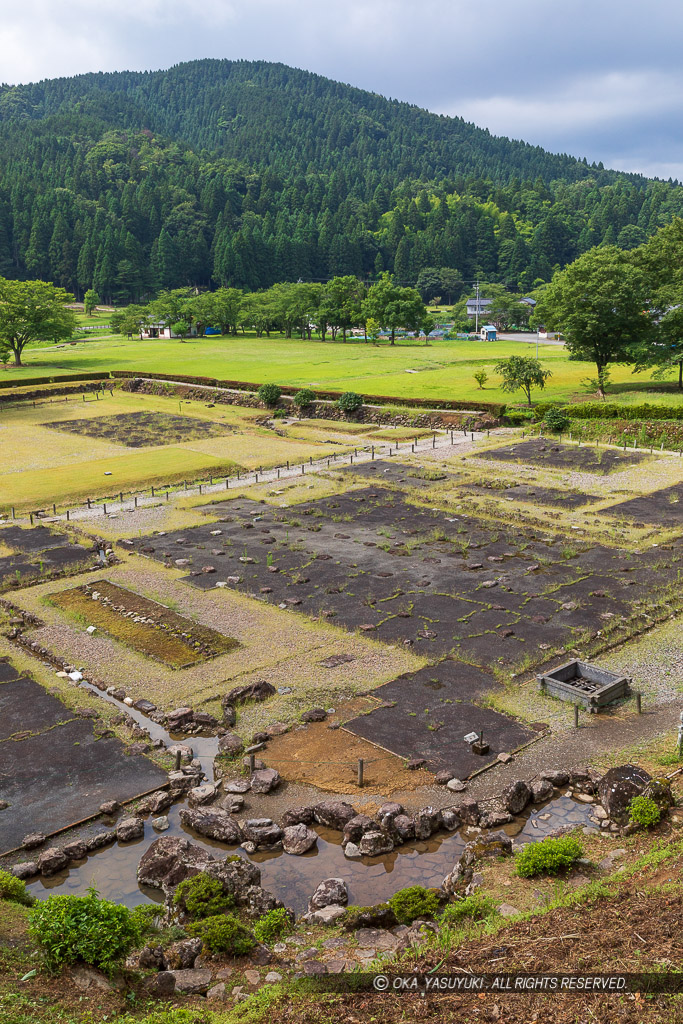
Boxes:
[535,246,653,394]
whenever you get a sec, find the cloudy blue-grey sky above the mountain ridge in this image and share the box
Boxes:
[0,0,683,179]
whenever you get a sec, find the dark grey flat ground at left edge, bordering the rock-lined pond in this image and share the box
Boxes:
[0,666,167,853]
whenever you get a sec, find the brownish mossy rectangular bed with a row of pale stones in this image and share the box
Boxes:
[50,580,240,669]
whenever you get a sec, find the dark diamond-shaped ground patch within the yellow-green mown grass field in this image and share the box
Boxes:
[41,413,232,447]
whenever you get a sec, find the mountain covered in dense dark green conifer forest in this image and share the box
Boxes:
[0,60,683,301]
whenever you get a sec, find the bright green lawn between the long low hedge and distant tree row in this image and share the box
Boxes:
[0,335,683,401]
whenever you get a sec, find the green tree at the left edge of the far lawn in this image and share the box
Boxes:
[0,278,77,367]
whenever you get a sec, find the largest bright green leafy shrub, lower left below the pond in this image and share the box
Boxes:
[29,889,139,971]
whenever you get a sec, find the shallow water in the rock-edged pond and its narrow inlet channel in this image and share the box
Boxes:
[29,680,591,913]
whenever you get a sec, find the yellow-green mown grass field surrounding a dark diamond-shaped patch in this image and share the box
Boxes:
[0,391,357,510]
